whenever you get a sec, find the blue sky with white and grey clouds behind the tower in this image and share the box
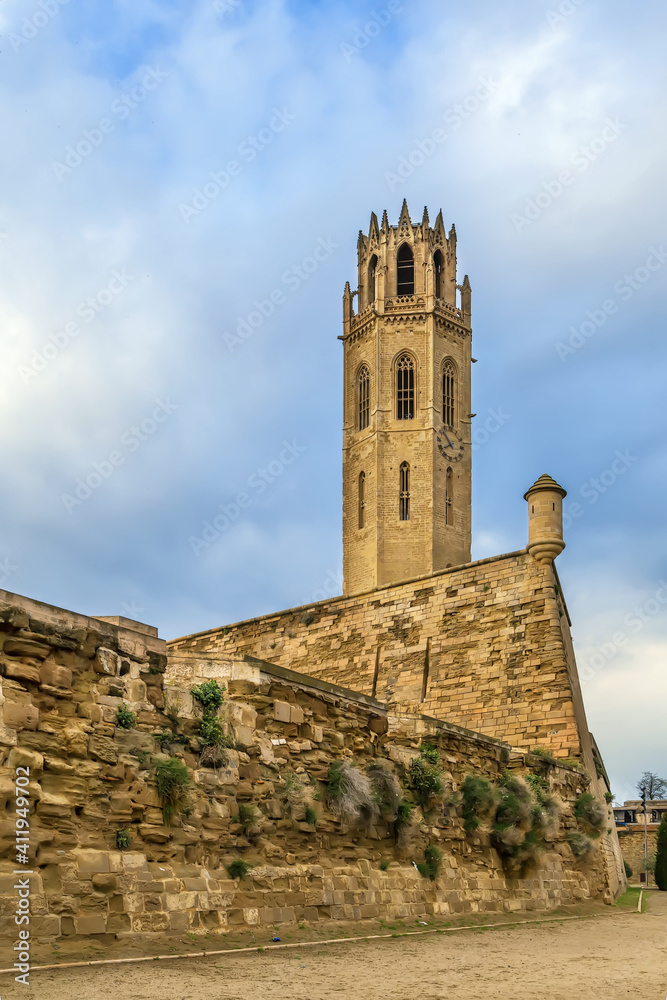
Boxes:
[0,0,667,800]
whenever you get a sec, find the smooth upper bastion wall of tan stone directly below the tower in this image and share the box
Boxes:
[169,552,594,756]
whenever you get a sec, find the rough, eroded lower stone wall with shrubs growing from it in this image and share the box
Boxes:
[0,592,614,940]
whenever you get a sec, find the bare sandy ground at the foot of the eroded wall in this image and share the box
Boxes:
[0,893,667,1000]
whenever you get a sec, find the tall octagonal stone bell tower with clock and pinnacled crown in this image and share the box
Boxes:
[340,201,471,594]
